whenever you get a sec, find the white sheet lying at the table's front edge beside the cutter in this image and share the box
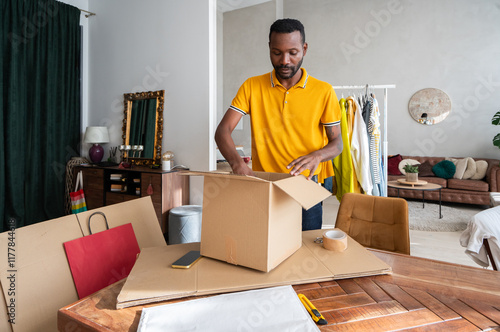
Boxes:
[137,286,319,332]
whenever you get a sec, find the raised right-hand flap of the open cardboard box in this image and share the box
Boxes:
[273,175,332,210]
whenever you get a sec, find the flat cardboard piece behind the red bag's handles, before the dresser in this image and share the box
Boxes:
[76,196,167,248]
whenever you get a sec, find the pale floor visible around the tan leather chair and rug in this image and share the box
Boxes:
[323,196,491,269]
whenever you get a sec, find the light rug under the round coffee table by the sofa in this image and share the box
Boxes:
[408,201,481,232]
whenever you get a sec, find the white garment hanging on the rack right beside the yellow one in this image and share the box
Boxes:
[347,97,373,195]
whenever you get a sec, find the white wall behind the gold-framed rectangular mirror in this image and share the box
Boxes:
[88,0,216,204]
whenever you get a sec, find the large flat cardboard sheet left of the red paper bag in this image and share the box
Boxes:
[0,215,82,332]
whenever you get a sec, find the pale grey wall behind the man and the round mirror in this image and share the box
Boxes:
[225,0,500,158]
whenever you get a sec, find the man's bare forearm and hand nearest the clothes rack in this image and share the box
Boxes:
[287,126,343,180]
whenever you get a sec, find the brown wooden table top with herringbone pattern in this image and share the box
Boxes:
[58,249,500,331]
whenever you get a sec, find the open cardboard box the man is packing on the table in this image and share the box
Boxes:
[182,172,331,272]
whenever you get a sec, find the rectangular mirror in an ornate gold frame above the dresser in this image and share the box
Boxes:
[122,90,165,165]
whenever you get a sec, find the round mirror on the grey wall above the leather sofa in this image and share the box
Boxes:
[408,88,451,126]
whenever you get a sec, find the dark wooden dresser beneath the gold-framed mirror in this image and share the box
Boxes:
[73,165,189,234]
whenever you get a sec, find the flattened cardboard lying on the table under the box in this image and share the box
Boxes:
[117,230,391,309]
